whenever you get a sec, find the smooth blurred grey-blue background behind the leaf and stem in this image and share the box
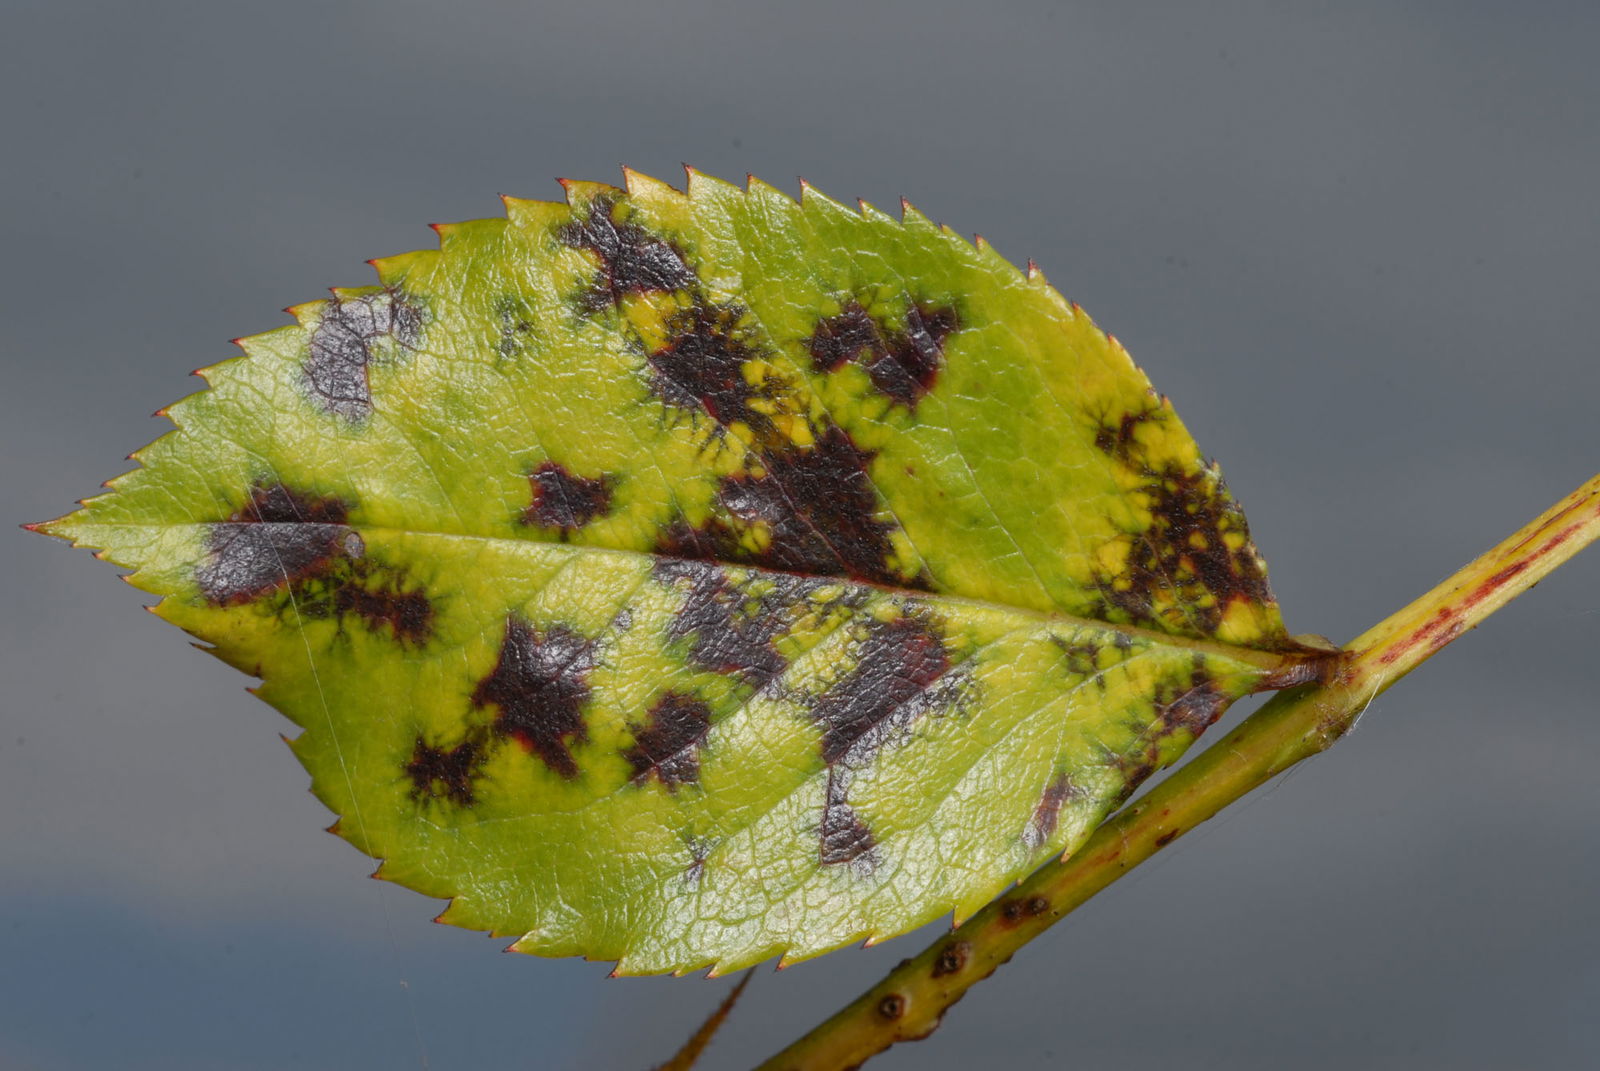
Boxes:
[0,0,1600,1071]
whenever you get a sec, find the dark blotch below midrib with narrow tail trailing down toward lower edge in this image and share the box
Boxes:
[810,605,968,872]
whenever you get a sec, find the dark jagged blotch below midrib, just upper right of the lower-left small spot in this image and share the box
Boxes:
[472,615,598,778]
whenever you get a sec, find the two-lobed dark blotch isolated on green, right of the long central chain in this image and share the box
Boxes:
[806,298,962,410]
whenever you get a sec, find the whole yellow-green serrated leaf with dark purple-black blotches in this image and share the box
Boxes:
[42,164,1306,973]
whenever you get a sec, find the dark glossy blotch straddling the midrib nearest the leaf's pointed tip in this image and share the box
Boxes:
[195,483,362,605]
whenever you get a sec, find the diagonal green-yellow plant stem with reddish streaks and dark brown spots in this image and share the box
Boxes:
[762,475,1600,1071]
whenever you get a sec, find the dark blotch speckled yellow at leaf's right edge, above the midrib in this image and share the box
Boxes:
[1094,400,1288,644]
